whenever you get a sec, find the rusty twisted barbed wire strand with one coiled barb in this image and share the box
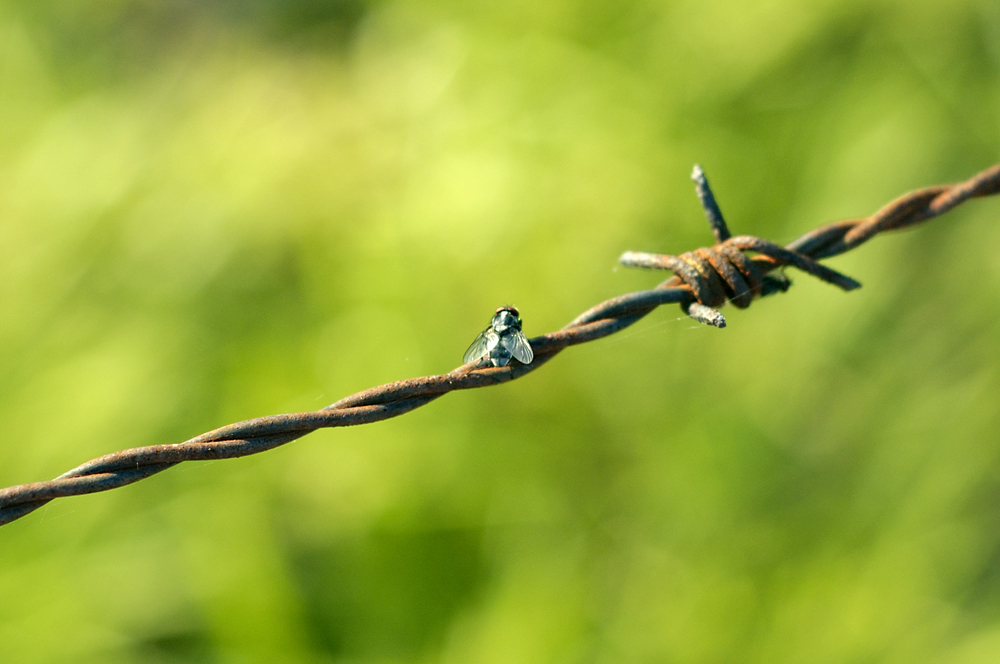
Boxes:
[0,164,1000,525]
